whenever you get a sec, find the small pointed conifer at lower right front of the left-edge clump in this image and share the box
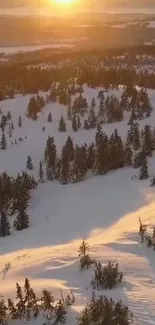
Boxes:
[14,202,29,231]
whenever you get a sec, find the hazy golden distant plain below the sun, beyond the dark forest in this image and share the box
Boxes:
[0,14,155,48]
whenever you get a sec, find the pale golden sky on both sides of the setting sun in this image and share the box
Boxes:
[0,0,155,13]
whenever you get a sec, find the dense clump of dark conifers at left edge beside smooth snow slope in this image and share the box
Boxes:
[0,172,37,237]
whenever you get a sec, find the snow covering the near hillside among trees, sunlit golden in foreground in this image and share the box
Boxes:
[0,86,155,325]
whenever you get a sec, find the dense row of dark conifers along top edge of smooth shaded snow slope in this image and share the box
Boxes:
[40,122,155,184]
